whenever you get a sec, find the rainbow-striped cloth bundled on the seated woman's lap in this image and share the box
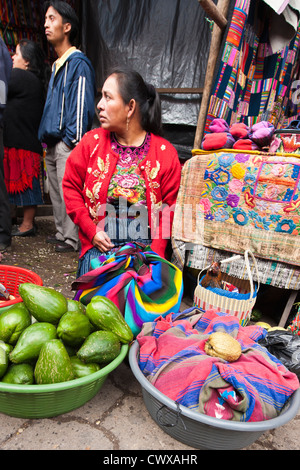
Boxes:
[72,243,183,335]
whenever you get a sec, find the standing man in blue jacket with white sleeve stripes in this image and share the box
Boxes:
[39,0,96,252]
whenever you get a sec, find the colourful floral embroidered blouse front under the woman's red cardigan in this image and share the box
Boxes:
[107,133,151,205]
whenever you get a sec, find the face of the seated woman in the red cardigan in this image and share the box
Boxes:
[97,74,129,133]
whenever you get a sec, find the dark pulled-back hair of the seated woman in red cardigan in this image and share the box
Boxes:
[109,67,162,135]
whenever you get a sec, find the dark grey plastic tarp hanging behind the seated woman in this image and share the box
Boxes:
[82,0,211,126]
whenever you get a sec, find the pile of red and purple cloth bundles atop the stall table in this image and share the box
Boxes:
[201,118,275,151]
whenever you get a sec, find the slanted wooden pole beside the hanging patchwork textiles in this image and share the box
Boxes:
[194,0,230,148]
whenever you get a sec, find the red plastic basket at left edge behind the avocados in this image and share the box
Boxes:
[0,264,43,309]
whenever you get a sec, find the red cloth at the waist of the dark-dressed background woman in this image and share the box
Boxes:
[3,147,41,194]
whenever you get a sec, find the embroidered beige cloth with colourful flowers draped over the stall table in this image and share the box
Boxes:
[173,149,300,289]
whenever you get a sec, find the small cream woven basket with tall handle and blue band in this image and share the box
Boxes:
[194,250,259,326]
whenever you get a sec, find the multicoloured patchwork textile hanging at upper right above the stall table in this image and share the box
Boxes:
[205,0,300,132]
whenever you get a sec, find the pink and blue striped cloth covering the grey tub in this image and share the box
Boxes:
[137,307,299,422]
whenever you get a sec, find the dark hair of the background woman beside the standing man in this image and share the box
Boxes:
[19,39,51,93]
